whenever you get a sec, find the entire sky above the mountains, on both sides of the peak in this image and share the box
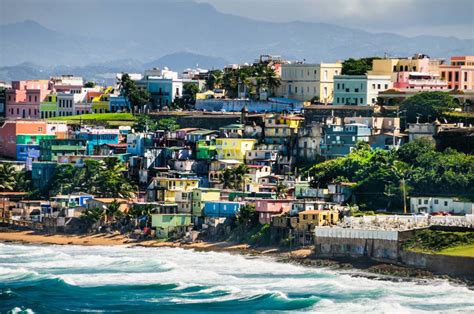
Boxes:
[0,0,474,39]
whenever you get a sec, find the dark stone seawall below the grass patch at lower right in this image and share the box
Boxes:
[399,251,474,280]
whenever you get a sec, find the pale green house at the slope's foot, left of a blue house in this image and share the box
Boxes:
[151,214,191,238]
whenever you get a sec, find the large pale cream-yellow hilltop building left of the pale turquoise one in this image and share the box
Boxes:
[279,63,342,103]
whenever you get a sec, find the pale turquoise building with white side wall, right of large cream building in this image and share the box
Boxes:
[333,75,393,106]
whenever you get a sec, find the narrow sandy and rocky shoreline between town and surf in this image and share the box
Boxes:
[0,229,474,289]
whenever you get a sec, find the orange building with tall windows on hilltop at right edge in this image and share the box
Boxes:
[439,56,474,90]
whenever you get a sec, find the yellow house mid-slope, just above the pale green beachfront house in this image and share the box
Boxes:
[154,177,199,202]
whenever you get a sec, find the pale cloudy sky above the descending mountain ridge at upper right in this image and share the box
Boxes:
[197,0,474,38]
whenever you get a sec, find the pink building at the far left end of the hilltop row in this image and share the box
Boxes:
[5,80,51,119]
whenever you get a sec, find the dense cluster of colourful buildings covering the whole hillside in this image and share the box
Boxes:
[0,55,474,237]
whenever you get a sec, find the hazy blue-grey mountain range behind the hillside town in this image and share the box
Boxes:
[0,0,474,80]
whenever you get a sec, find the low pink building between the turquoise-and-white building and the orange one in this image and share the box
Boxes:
[393,71,448,90]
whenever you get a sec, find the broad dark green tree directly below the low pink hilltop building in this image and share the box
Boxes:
[400,91,459,123]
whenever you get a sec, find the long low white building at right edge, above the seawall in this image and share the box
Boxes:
[410,196,474,214]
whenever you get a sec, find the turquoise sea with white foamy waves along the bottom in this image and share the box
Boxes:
[0,243,474,313]
